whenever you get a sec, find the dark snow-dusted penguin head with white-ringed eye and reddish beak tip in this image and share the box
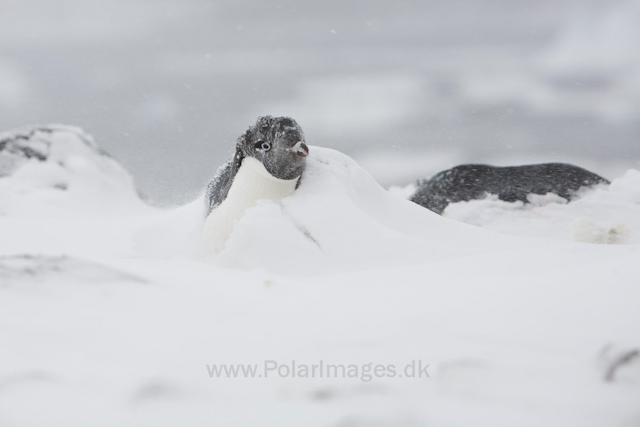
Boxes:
[237,116,309,180]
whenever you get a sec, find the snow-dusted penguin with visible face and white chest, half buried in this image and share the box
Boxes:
[203,116,309,252]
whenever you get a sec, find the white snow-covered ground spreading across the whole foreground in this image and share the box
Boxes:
[0,147,640,427]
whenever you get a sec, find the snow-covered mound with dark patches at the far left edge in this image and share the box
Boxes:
[0,125,149,216]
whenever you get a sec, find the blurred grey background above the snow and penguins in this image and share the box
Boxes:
[0,0,640,205]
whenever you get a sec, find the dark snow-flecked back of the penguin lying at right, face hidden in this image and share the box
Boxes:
[409,163,609,215]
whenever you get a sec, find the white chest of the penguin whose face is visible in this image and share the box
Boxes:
[203,157,298,252]
